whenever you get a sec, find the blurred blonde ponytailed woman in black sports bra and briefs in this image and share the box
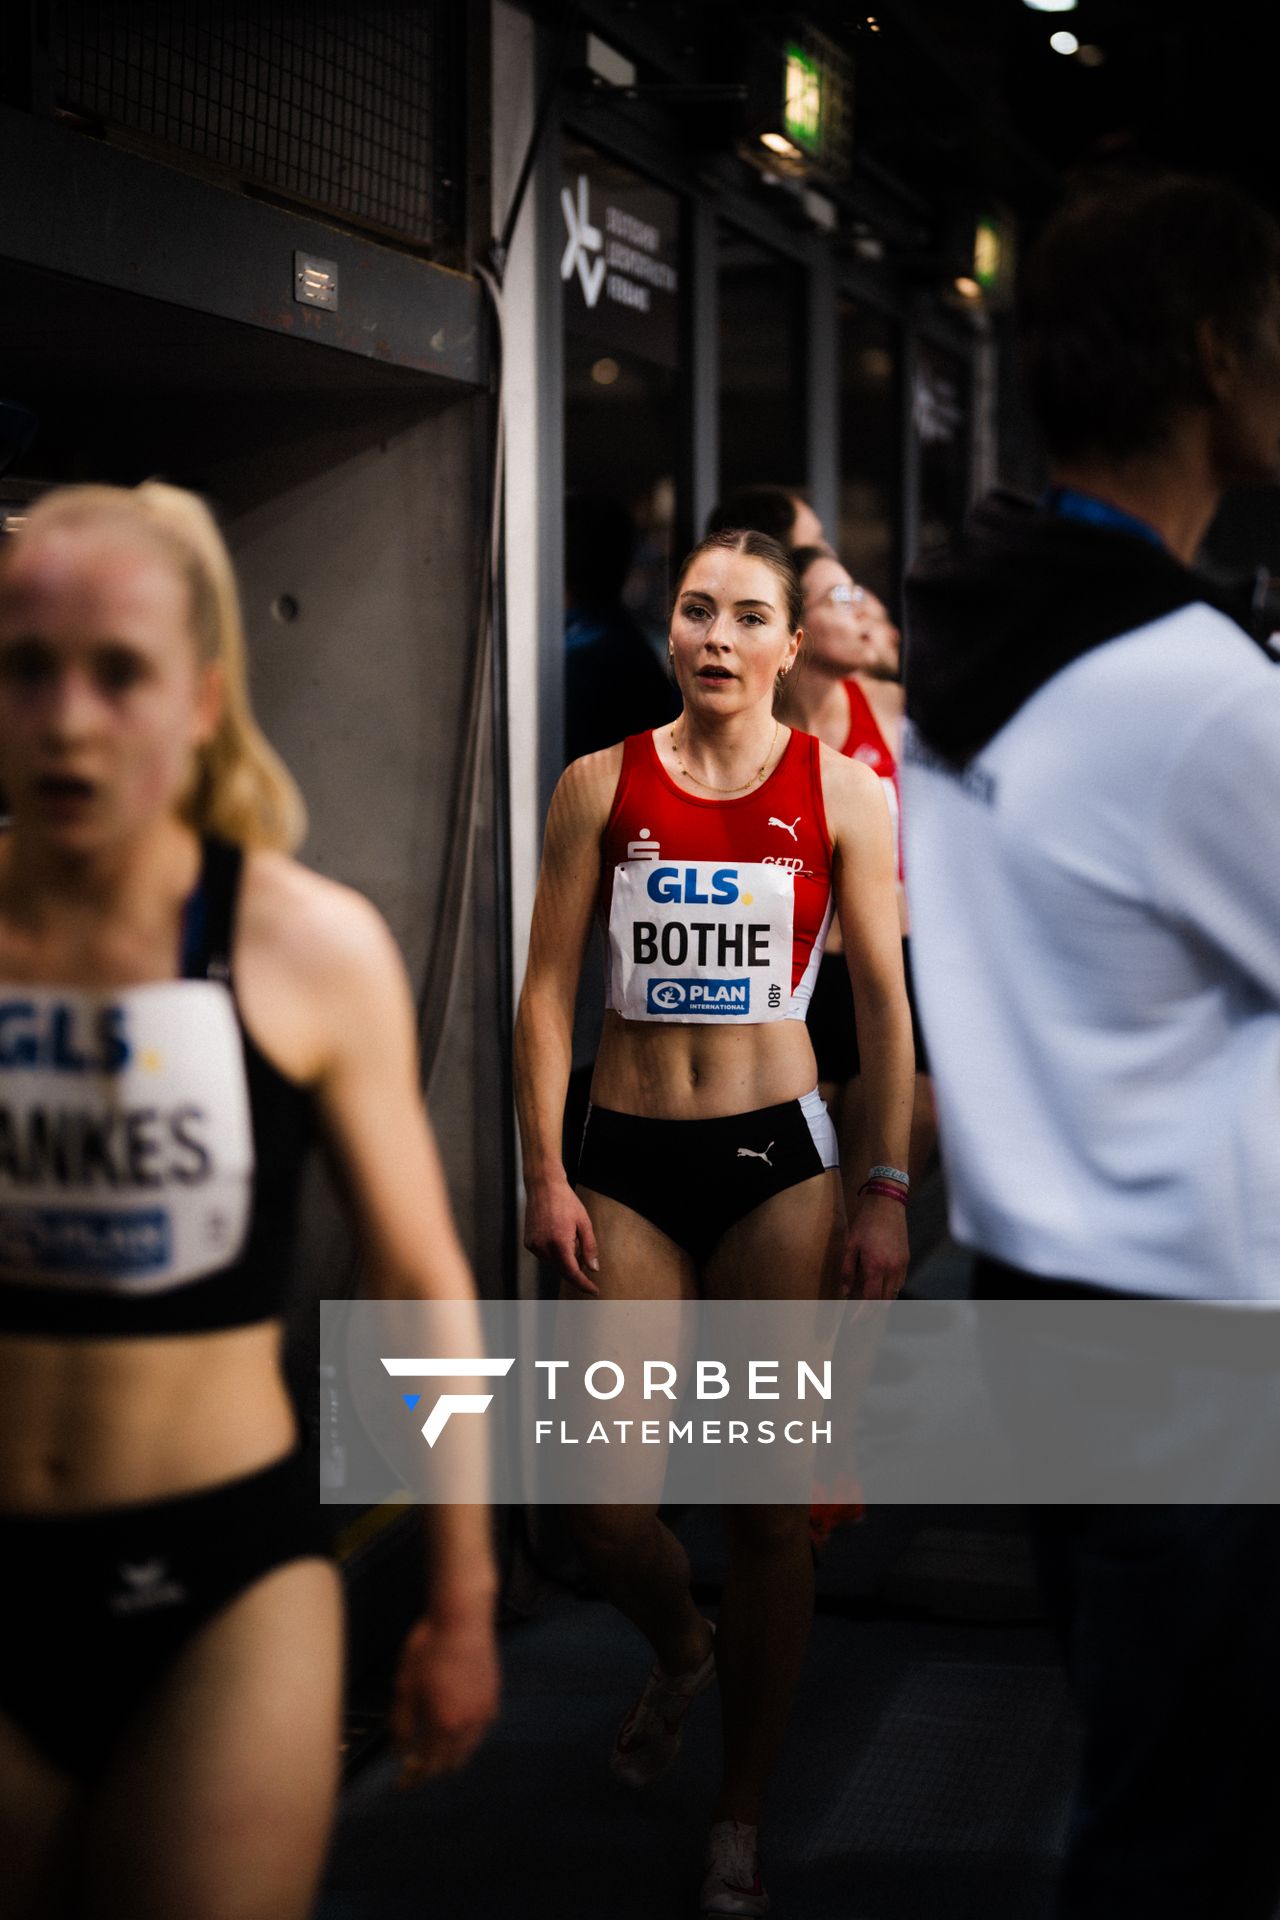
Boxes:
[0,486,497,1920]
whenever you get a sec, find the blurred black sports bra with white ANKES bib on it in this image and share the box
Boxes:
[0,839,315,1338]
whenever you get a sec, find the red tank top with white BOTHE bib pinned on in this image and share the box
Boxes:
[601,732,833,1025]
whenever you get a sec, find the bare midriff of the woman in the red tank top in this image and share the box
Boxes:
[591,1014,818,1119]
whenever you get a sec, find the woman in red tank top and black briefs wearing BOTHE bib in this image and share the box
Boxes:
[516,532,913,1914]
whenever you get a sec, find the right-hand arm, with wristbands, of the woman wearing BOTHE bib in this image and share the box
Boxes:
[821,747,915,1300]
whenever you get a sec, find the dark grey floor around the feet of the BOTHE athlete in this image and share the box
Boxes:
[320,1221,1077,1920]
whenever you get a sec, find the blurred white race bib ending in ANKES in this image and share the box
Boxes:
[0,979,253,1294]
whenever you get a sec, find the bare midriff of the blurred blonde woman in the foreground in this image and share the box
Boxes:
[0,1321,296,1513]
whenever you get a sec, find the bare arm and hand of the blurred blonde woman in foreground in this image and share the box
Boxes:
[238,856,499,1778]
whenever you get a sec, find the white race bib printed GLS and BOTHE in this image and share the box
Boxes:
[608,860,794,1025]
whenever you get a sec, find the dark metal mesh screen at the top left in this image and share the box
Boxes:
[50,0,439,248]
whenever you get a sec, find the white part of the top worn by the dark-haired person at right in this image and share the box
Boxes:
[902,605,1280,1300]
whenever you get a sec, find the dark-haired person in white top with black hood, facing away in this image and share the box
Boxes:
[904,177,1280,1920]
